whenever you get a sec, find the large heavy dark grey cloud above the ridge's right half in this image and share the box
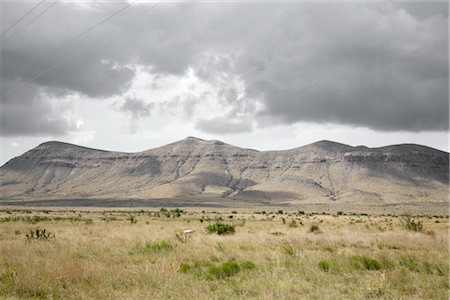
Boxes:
[236,4,449,131]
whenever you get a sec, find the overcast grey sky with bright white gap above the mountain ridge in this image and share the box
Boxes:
[0,0,449,164]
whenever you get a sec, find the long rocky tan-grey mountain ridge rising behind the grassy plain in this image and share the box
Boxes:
[0,137,449,204]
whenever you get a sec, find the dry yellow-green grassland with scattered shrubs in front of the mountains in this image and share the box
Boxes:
[0,209,449,299]
